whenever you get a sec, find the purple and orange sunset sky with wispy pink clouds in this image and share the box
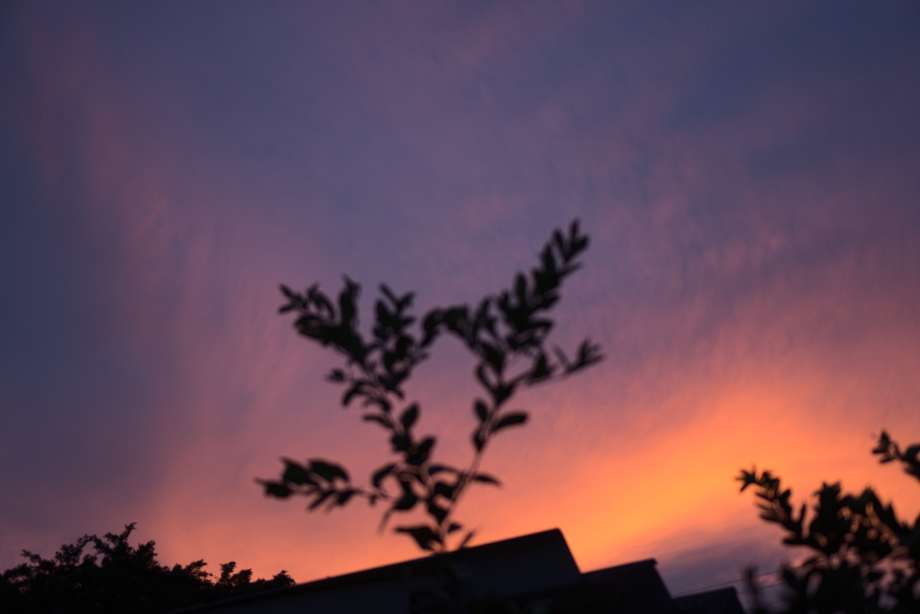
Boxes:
[0,0,920,608]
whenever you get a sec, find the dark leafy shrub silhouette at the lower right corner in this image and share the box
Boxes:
[738,431,920,614]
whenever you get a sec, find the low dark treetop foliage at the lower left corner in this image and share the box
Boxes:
[0,523,294,614]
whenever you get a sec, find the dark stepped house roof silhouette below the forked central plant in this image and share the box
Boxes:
[164,529,740,614]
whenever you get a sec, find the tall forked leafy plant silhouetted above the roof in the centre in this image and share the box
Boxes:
[258,220,602,552]
